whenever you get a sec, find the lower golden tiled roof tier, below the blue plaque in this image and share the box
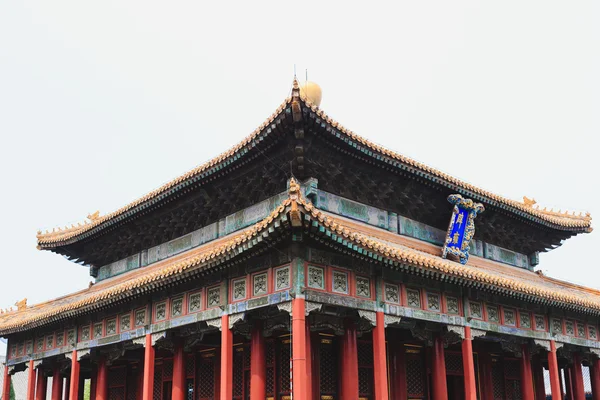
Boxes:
[0,180,600,335]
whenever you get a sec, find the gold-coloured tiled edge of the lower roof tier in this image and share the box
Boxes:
[0,180,600,334]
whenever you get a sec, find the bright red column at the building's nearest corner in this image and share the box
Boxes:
[292,298,308,400]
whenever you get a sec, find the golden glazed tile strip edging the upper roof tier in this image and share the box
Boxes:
[37,81,592,247]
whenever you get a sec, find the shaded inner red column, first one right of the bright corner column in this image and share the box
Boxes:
[340,320,358,400]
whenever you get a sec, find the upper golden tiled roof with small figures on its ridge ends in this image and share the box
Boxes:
[37,81,592,253]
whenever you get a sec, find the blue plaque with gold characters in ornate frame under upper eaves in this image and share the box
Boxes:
[442,194,485,264]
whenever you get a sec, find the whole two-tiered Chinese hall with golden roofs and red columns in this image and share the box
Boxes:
[0,80,600,400]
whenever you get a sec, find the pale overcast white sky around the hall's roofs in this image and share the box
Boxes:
[0,0,600,354]
